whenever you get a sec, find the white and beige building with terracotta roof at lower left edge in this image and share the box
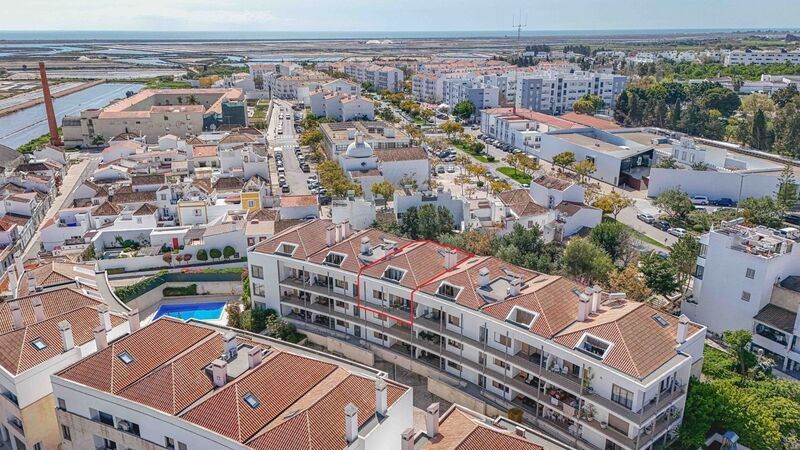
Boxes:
[0,286,131,450]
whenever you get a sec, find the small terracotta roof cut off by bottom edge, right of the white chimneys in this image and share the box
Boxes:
[422,407,543,450]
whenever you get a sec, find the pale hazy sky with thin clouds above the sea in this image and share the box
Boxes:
[0,0,800,31]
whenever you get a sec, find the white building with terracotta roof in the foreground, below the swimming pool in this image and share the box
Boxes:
[50,317,413,450]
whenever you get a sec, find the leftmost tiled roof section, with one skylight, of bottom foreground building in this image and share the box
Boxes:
[59,317,213,394]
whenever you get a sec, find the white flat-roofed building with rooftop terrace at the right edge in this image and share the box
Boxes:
[681,219,800,377]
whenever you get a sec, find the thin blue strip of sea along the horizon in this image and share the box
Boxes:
[0,27,797,43]
